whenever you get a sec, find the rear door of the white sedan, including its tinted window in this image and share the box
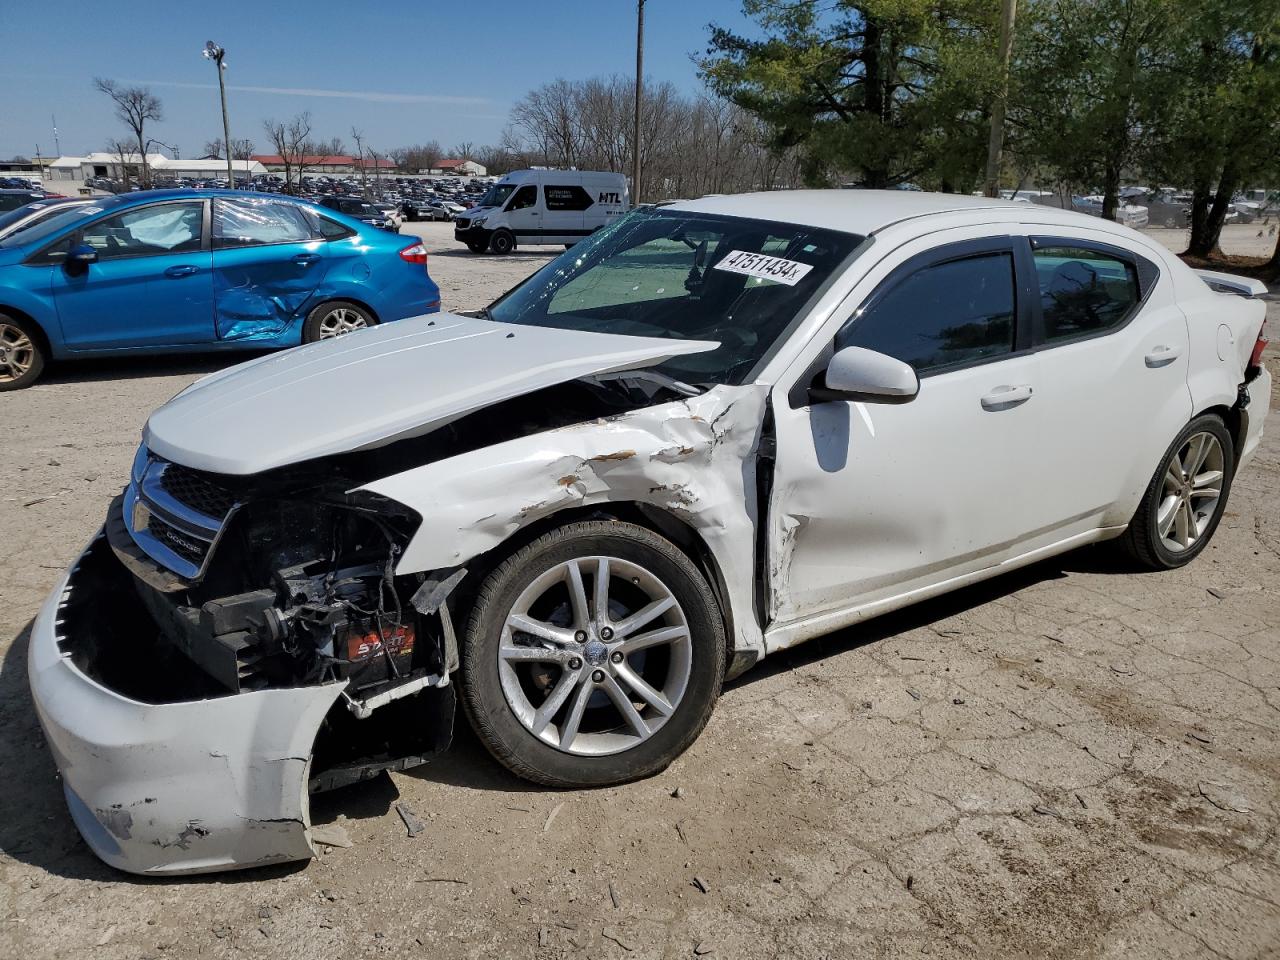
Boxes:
[1013,235,1192,548]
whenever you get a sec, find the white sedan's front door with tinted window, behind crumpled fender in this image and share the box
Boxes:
[768,238,1038,639]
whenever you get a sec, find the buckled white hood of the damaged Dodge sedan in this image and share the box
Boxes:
[142,314,718,475]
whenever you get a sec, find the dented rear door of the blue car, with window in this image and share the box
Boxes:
[212,197,328,340]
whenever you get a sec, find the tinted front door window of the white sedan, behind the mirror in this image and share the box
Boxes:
[836,252,1015,372]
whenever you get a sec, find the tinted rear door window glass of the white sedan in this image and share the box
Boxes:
[1034,246,1142,343]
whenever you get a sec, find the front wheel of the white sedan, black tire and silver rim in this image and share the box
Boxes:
[461,521,726,787]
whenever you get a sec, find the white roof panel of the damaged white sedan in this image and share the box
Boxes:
[663,189,1097,237]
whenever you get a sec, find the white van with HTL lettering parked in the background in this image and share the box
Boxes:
[453,170,631,253]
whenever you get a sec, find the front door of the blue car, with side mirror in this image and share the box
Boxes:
[52,200,214,351]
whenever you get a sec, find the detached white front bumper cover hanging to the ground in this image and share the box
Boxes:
[28,534,344,874]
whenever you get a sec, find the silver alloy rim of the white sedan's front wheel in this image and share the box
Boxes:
[498,557,692,756]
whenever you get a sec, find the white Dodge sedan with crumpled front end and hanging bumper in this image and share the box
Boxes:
[29,191,1271,873]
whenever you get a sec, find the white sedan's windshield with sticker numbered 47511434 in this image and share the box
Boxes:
[489,210,863,384]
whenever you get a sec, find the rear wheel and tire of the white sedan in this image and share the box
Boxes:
[1120,413,1235,570]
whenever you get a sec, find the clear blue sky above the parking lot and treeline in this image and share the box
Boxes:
[0,0,750,159]
